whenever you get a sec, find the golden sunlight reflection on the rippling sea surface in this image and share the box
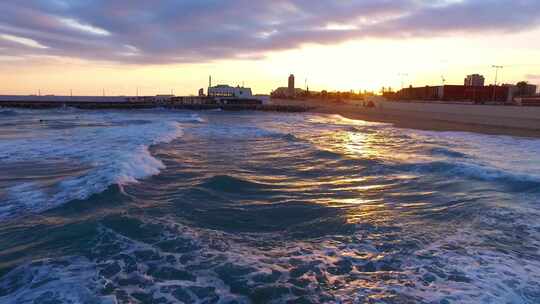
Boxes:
[304,122,423,224]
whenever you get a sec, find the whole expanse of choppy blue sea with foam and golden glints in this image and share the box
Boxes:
[0,109,540,303]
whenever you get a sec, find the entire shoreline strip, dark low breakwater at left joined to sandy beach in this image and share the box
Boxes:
[0,97,540,138]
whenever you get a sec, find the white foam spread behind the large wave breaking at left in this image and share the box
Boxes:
[0,113,188,219]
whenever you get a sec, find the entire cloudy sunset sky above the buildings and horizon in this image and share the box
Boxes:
[0,0,540,95]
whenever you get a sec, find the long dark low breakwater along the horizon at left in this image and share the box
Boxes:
[0,101,311,113]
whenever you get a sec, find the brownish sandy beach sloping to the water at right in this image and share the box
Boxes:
[271,99,540,138]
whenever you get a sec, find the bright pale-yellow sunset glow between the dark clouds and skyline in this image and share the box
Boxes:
[0,31,540,95]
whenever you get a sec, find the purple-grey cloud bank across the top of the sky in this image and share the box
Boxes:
[0,0,540,63]
